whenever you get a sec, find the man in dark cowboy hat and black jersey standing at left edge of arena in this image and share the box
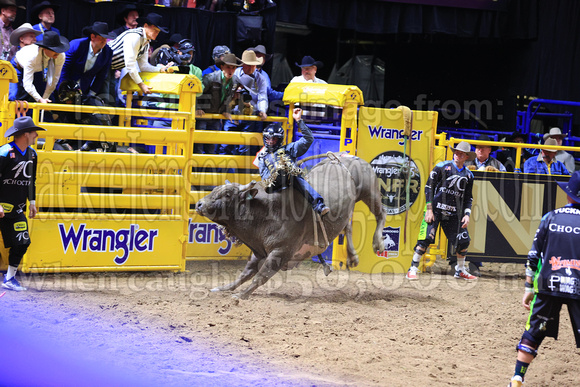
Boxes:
[0,117,45,292]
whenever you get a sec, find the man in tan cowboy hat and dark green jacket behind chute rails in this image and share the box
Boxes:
[194,53,241,154]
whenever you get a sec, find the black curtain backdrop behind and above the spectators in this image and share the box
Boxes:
[15,0,580,135]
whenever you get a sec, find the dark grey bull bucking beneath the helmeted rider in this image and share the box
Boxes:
[196,156,386,299]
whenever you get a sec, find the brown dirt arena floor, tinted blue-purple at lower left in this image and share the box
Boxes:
[0,261,580,386]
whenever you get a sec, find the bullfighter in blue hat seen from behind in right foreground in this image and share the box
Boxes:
[509,172,580,387]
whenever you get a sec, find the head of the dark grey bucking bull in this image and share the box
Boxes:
[195,180,258,223]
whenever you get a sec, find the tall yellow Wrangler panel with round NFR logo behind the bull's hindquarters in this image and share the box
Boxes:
[333,107,437,273]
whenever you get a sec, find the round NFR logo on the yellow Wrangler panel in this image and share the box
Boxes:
[371,151,421,215]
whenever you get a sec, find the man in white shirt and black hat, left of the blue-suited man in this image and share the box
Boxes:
[15,31,69,103]
